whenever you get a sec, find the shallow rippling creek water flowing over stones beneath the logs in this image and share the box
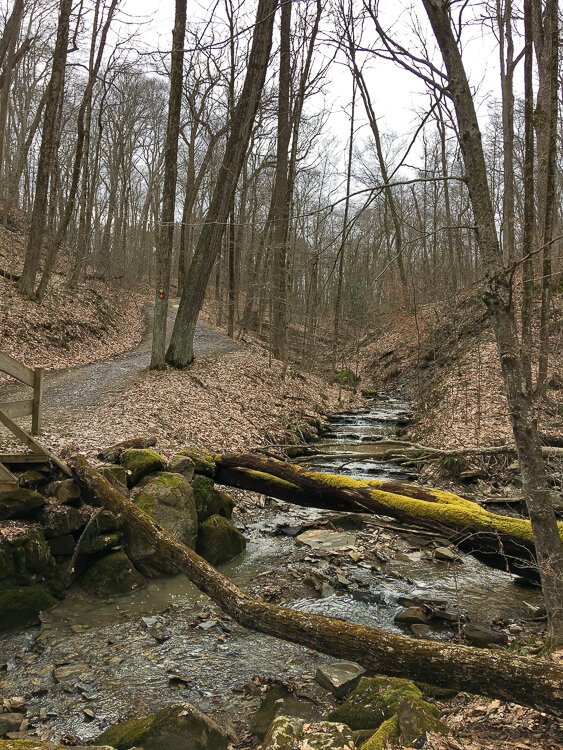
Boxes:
[0,397,540,741]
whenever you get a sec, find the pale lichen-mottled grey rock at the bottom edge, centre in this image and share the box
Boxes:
[262,716,355,750]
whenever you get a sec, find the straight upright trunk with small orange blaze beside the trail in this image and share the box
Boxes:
[151,0,187,370]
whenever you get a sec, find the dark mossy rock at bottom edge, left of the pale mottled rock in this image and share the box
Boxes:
[97,703,228,750]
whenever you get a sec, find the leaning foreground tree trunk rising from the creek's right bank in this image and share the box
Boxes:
[423,0,563,646]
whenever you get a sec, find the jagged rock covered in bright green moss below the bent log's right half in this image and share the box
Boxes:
[329,677,448,750]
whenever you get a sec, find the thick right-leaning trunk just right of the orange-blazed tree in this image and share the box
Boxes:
[166,0,278,367]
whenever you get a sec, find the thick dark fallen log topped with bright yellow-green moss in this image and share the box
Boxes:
[182,449,563,582]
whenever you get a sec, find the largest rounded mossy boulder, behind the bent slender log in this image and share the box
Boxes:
[125,471,198,576]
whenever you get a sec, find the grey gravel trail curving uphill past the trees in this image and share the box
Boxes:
[0,305,240,414]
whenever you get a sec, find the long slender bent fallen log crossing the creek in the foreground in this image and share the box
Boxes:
[68,456,563,716]
